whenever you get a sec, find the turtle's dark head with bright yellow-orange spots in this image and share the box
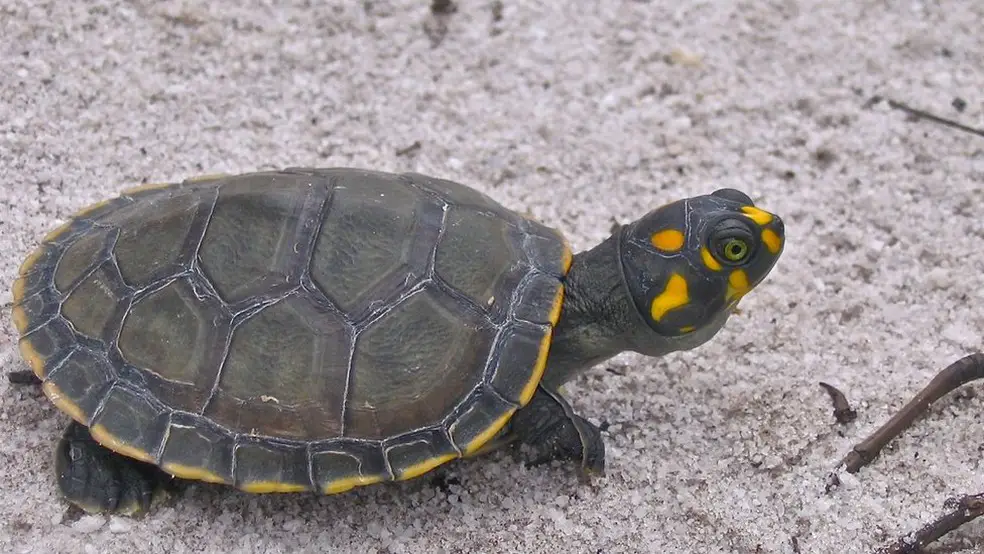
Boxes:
[620,189,785,352]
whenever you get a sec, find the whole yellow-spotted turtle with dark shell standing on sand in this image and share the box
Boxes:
[12,167,784,515]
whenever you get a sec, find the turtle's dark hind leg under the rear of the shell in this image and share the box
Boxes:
[55,421,170,515]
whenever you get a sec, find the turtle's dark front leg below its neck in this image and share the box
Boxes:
[510,387,605,477]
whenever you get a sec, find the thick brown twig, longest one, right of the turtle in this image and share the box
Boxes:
[840,353,984,473]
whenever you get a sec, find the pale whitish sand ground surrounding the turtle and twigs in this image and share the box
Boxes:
[0,0,984,554]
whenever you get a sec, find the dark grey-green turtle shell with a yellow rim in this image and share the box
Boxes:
[13,168,571,493]
